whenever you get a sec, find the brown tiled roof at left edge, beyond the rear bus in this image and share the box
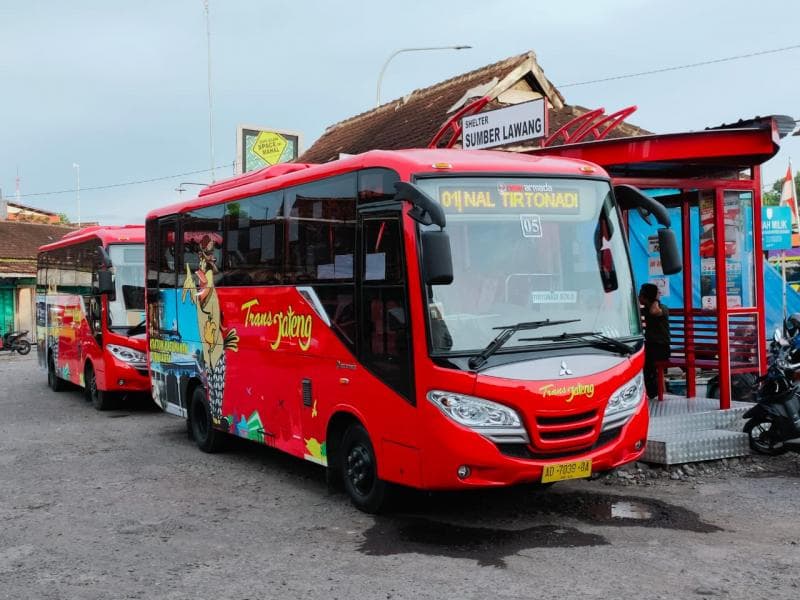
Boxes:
[0,221,73,276]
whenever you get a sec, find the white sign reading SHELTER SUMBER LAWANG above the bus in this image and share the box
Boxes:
[461,98,547,150]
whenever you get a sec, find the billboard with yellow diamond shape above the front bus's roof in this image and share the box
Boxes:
[236,125,302,175]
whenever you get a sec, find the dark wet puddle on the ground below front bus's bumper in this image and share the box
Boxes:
[359,490,721,568]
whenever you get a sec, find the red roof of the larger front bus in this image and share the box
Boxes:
[147,148,608,219]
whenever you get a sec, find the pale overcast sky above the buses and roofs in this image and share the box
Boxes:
[0,0,800,223]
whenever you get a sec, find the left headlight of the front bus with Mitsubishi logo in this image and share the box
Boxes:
[428,390,529,444]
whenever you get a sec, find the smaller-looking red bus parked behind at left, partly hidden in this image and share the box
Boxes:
[36,225,150,410]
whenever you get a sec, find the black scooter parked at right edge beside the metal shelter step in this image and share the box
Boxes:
[743,329,800,456]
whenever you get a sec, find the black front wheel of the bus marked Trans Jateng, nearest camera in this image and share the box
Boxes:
[340,423,387,514]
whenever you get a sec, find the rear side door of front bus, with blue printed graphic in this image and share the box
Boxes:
[147,216,184,417]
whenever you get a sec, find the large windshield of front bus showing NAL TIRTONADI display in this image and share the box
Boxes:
[417,177,641,355]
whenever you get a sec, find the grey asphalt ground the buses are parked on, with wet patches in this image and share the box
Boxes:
[0,354,800,600]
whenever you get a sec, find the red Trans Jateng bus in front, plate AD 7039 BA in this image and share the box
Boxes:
[146,150,679,511]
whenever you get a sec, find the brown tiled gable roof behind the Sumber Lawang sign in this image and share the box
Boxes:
[298,52,649,163]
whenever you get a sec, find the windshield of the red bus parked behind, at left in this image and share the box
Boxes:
[108,244,144,329]
